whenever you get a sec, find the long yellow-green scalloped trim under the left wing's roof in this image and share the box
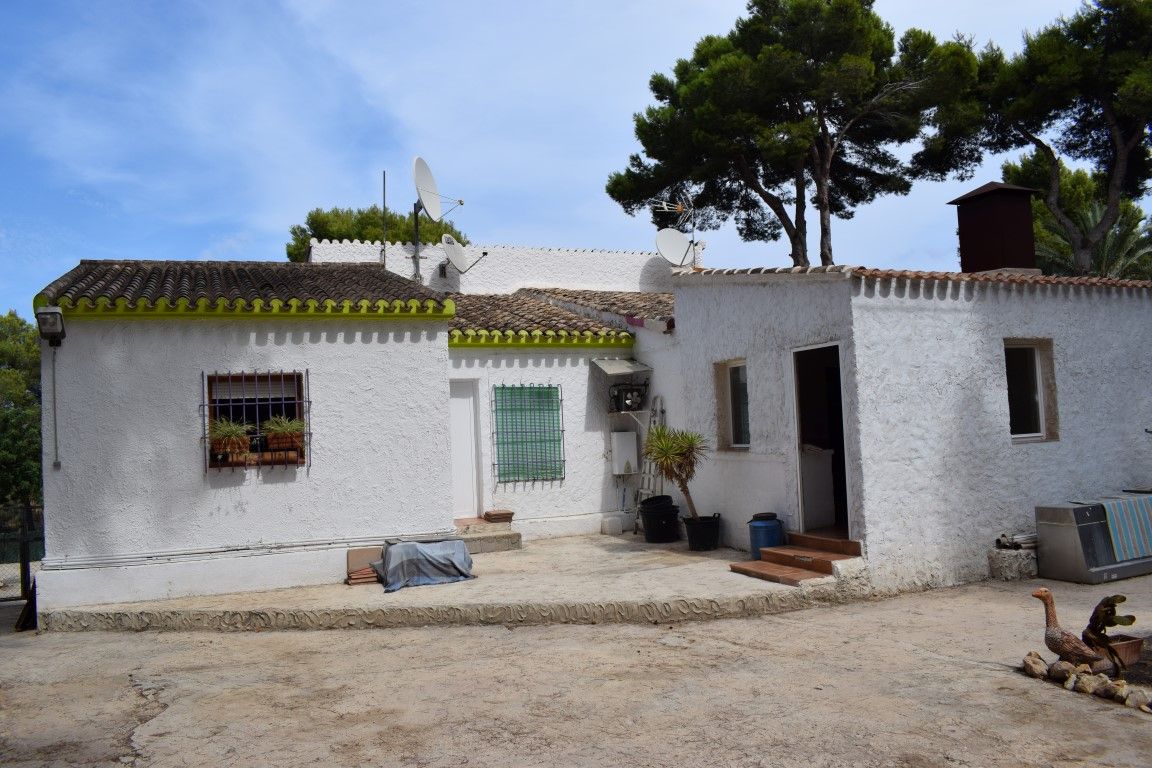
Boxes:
[32,294,456,320]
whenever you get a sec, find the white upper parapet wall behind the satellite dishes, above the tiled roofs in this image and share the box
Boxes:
[312,239,672,294]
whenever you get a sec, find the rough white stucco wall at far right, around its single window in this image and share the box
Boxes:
[852,281,1152,588]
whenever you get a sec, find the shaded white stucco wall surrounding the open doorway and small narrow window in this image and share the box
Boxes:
[669,274,861,549]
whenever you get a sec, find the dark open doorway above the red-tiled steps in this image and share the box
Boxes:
[794,344,849,539]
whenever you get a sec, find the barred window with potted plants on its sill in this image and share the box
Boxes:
[200,371,312,469]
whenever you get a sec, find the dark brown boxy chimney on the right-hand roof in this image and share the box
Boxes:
[948,182,1037,272]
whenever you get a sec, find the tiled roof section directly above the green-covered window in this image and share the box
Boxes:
[448,292,616,334]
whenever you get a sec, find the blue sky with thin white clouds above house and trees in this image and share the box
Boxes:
[0,0,1079,317]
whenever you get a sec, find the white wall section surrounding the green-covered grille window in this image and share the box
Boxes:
[450,349,630,539]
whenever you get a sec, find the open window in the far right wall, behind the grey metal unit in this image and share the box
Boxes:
[1005,339,1058,441]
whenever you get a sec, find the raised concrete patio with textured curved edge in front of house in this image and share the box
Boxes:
[40,534,862,631]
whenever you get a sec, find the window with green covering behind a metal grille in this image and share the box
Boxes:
[492,385,564,482]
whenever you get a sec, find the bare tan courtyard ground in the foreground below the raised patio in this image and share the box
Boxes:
[0,577,1152,768]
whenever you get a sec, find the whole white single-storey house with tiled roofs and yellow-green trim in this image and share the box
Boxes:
[36,188,1152,611]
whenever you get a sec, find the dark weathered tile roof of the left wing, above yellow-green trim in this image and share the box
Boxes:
[34,259,444,306]
